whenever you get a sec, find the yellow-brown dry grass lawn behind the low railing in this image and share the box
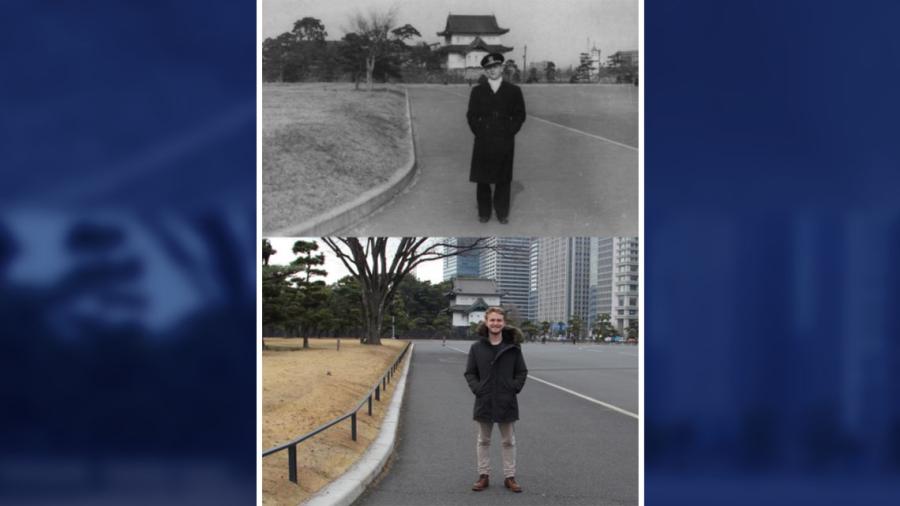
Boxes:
[262,338,406,506]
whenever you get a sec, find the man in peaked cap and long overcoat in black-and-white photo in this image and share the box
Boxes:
[466,53,525,223]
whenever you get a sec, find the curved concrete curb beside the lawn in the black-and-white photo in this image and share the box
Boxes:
[264,87,416,237]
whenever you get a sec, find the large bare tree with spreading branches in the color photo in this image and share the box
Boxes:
[322,237,486,344]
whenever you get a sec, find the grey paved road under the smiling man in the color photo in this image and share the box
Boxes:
[355,341,638,506]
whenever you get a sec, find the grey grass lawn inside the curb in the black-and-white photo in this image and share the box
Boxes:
[262,83,409,231]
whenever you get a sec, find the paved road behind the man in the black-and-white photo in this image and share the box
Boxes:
[340,86,638,236]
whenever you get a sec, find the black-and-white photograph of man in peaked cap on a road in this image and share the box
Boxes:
[261,0,641,237]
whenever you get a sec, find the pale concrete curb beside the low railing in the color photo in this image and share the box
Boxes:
[302,343,415,506]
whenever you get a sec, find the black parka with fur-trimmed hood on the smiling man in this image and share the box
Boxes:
[465,323,528,423]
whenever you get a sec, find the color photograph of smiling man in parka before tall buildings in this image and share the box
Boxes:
[261,237,641,505]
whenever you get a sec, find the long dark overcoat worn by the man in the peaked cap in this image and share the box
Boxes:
[466,81,525,183]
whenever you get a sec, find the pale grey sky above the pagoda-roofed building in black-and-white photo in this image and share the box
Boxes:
[262,0,639,68]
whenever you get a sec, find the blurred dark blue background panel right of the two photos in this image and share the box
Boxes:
[642,1,900,505]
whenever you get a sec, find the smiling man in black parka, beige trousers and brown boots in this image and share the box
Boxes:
[465,307,528,492]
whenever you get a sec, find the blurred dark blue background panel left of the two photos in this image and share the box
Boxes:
[0,0,258,504]
